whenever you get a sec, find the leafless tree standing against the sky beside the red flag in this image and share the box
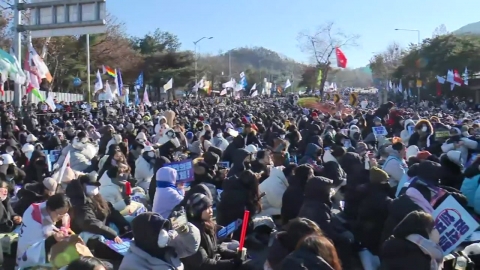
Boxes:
[298,22,359,95]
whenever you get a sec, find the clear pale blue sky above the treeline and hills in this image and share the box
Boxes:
[107,0,480,67]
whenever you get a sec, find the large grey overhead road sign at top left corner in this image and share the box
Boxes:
[18,0,107,38]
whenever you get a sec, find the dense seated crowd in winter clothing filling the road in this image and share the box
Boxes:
[0,94,480,270]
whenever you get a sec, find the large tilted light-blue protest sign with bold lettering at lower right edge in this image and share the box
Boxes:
[433,196,478,255]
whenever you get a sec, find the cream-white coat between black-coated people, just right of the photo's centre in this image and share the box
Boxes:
[259,167,288,216]
